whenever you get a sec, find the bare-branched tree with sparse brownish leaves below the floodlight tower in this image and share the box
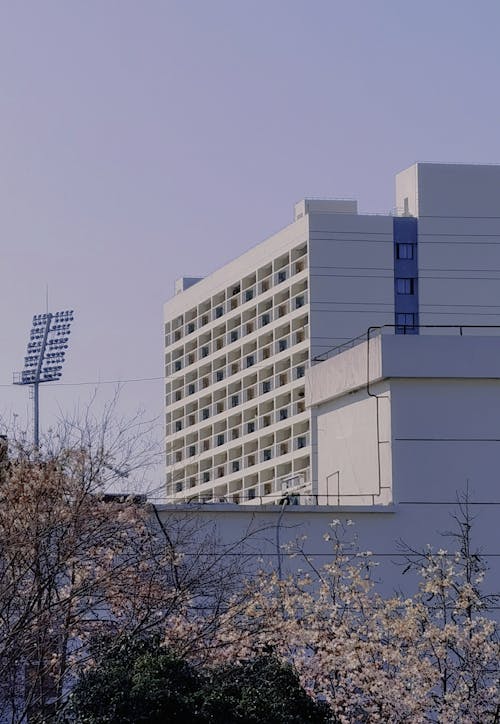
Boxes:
[0,398,260,724]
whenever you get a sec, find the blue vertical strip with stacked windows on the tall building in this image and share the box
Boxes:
[393,216,418,334]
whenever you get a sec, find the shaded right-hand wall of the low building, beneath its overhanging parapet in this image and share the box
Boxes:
[391,379,500,505]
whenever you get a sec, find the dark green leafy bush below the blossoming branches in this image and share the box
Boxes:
[66,638,332,724]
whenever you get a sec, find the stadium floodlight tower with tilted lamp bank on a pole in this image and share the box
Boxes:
[14,309,73,448]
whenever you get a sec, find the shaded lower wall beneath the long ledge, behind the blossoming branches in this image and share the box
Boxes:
[156,499,500,594]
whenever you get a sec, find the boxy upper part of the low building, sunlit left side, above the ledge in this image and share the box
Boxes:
[306,335,500,505]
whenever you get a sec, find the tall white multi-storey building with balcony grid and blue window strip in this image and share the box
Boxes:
[165,164,500,504]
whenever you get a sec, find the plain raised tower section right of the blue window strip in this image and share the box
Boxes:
[396,163,500,325]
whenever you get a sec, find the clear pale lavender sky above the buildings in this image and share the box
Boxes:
[0,0,500,490]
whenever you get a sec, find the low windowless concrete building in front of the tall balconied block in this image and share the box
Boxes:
[161,327,500,594]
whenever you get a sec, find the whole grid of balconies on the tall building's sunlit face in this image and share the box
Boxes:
[165,245,310,503]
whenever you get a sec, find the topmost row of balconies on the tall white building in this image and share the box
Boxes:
[165,257,307,345]
